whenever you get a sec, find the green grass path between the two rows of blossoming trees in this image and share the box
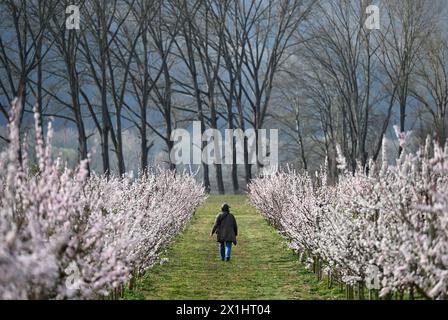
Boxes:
[125,195,344,299]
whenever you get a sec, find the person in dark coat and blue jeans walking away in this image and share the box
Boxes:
[210,203,238,261]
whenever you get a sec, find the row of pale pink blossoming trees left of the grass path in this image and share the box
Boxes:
[0,99,206,299]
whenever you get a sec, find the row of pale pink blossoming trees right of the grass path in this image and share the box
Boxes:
[249,134,448,299]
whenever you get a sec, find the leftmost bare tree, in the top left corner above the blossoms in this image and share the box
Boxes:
[0,0,57,141]
